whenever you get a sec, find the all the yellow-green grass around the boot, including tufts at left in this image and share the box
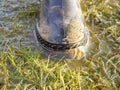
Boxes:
[0,0,120,90]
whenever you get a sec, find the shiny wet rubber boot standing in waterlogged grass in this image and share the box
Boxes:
[35,0,89,60]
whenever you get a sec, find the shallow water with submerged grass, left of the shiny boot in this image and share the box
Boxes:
[0,0,40,49]
